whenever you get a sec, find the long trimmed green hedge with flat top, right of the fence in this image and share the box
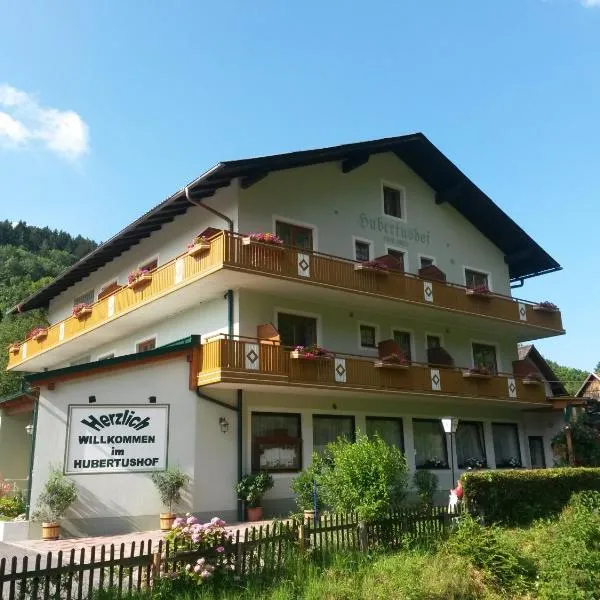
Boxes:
[461,467,600,525]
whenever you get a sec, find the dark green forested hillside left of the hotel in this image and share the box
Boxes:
[0,221,96,396]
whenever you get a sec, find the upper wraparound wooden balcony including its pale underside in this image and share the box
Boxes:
[7,232,564,371]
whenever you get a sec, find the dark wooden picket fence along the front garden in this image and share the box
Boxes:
[0,508,456,600]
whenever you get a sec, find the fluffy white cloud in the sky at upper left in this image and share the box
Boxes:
[0,85,89,159]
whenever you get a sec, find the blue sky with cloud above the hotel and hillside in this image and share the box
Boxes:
[0,0,600,369]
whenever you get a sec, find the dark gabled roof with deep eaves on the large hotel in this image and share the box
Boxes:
[12,133,561,311]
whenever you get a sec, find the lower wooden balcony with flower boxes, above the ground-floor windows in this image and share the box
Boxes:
[198,336,548,406]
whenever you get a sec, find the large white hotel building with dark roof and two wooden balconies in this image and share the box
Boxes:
[0,134,564,533]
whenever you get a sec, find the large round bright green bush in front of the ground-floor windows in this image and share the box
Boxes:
[318,433,408,520]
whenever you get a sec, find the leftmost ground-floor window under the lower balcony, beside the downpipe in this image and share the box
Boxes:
[251,412,302,472]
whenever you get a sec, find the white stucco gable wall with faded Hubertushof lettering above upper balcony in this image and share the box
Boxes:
[239,153,510,294]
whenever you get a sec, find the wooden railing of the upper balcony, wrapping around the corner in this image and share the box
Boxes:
[8,232,563,369]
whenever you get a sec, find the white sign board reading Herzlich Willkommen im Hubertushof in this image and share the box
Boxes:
[65,404,169,475]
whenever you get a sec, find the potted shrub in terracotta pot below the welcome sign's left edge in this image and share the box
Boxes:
[32,467,77,540]
